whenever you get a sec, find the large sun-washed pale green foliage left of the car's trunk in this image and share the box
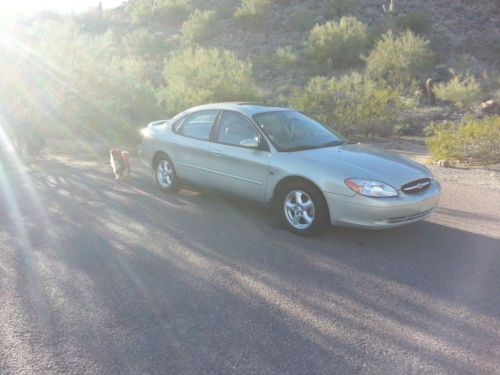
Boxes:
[0,22,161,144]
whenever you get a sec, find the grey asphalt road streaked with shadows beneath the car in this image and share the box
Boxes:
[0,154,500,374]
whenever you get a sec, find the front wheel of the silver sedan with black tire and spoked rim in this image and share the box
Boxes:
[276,181,329,236]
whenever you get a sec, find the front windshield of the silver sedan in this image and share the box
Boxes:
[253,110,346,152]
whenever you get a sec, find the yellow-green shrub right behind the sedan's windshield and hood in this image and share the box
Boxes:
[290,73,407,136]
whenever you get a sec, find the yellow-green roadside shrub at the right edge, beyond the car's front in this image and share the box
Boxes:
[425,116,500,164]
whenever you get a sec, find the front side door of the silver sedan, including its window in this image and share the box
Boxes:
[208,111,270,202]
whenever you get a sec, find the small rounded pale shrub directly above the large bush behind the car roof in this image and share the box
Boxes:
[181,9,218,43]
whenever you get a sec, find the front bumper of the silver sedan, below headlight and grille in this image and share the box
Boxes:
[324,181,441,229]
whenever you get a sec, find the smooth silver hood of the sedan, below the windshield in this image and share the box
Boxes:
[297,144,432,189]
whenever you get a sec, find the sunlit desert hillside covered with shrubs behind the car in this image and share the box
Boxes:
[0,0,500,163]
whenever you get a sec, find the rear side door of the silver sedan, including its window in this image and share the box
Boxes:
[172,110,218,186]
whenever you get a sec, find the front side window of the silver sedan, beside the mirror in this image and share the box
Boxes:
[217,111,260,146]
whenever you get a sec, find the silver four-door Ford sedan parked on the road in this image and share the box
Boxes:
[139,103,441,235]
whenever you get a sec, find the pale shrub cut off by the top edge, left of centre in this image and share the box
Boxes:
[127,0,192,25]
